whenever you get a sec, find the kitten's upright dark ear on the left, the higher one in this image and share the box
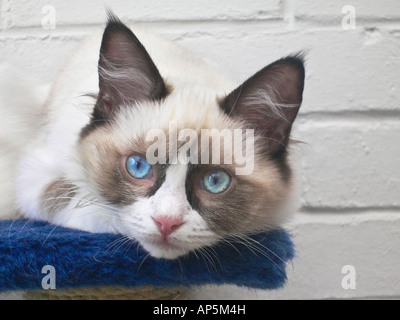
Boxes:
[94,13,167,119]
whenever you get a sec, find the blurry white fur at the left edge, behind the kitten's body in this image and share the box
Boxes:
[0,64,49,219]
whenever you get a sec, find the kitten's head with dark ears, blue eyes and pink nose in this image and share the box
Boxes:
[79,17,304,259]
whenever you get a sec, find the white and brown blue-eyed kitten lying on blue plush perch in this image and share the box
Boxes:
[2,15,304,259]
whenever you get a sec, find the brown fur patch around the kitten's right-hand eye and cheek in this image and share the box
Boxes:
[186,154,288,235]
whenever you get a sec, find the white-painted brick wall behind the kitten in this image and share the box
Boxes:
[0,0,400,299]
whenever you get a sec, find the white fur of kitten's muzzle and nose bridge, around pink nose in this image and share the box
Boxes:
[120,164,218,259]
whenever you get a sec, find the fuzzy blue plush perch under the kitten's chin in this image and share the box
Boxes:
[0,219,294,291]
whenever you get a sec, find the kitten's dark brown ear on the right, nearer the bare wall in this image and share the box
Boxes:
[220,55,305,156]
